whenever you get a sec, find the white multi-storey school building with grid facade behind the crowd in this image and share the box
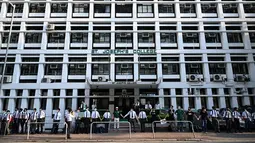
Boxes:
[0,0,255,116]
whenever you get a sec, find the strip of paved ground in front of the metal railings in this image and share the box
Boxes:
[0,132,255,143]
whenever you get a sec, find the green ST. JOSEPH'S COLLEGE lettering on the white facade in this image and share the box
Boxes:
[92,49,156,55]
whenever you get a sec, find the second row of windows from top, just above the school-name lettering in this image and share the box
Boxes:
[2,33,255,43]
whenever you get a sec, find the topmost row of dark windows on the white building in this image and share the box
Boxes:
[3,3,255,13]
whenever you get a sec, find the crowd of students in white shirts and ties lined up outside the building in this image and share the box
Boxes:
[0,103,255,138]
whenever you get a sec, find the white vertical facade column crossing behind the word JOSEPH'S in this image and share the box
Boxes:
[109,21,115,82]
